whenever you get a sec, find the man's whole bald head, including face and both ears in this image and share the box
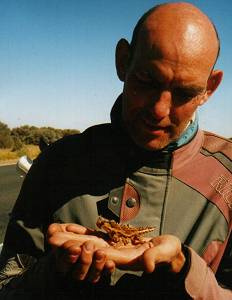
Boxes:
[116,2,223,150]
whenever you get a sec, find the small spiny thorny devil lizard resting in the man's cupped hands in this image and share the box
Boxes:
[96,216,155,248]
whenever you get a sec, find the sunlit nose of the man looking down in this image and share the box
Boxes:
[149,91,172,120]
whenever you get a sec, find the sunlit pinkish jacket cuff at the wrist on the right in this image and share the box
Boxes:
[185,248,232,300]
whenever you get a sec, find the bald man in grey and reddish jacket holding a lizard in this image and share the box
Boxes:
[0,3,232,300]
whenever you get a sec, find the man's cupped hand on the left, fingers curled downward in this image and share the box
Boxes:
[47,224,115,283]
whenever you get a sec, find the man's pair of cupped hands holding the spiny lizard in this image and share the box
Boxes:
[48,224,185,282]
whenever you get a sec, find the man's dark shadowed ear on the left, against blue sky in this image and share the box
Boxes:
[115,39,130,81]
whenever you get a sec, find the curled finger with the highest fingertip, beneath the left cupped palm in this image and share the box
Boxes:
[73,241,95,280]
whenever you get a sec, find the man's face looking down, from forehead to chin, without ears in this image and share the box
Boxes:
[122,29,209,150]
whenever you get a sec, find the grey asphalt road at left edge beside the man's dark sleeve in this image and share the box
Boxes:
[0,165,23,243]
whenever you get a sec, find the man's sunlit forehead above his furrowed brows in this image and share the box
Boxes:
[134,23,217,77]
